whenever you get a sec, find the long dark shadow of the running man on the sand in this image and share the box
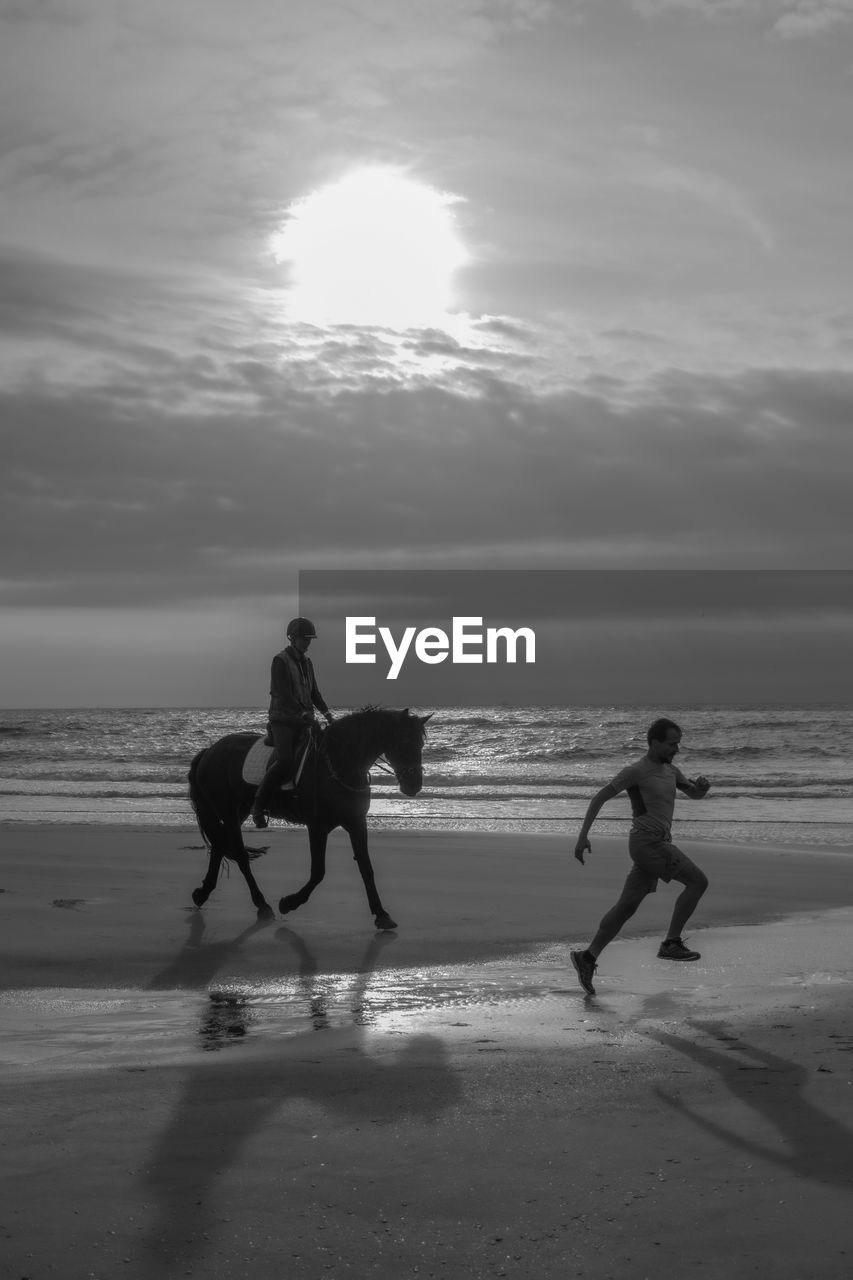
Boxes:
[647,1020,853,1188]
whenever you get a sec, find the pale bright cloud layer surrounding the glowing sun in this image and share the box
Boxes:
[0,0,849,412]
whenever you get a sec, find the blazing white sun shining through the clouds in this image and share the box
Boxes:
[273,168,466,329]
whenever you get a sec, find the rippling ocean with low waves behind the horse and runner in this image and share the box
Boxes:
[0,707,853,851]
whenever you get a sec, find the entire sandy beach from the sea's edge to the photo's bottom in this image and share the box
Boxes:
[0,824,853,1280]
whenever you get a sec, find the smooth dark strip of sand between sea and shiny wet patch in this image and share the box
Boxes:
[0,824,853,988]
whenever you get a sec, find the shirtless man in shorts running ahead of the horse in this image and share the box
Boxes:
[571,719,711,996]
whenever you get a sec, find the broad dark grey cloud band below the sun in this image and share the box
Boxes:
[0,371,853,622]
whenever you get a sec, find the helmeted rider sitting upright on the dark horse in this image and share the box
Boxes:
[252,618,332,827]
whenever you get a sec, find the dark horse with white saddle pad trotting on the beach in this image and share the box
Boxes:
[183,707,429,929]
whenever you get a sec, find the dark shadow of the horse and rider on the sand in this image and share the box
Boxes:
[140,925,460,1275]
